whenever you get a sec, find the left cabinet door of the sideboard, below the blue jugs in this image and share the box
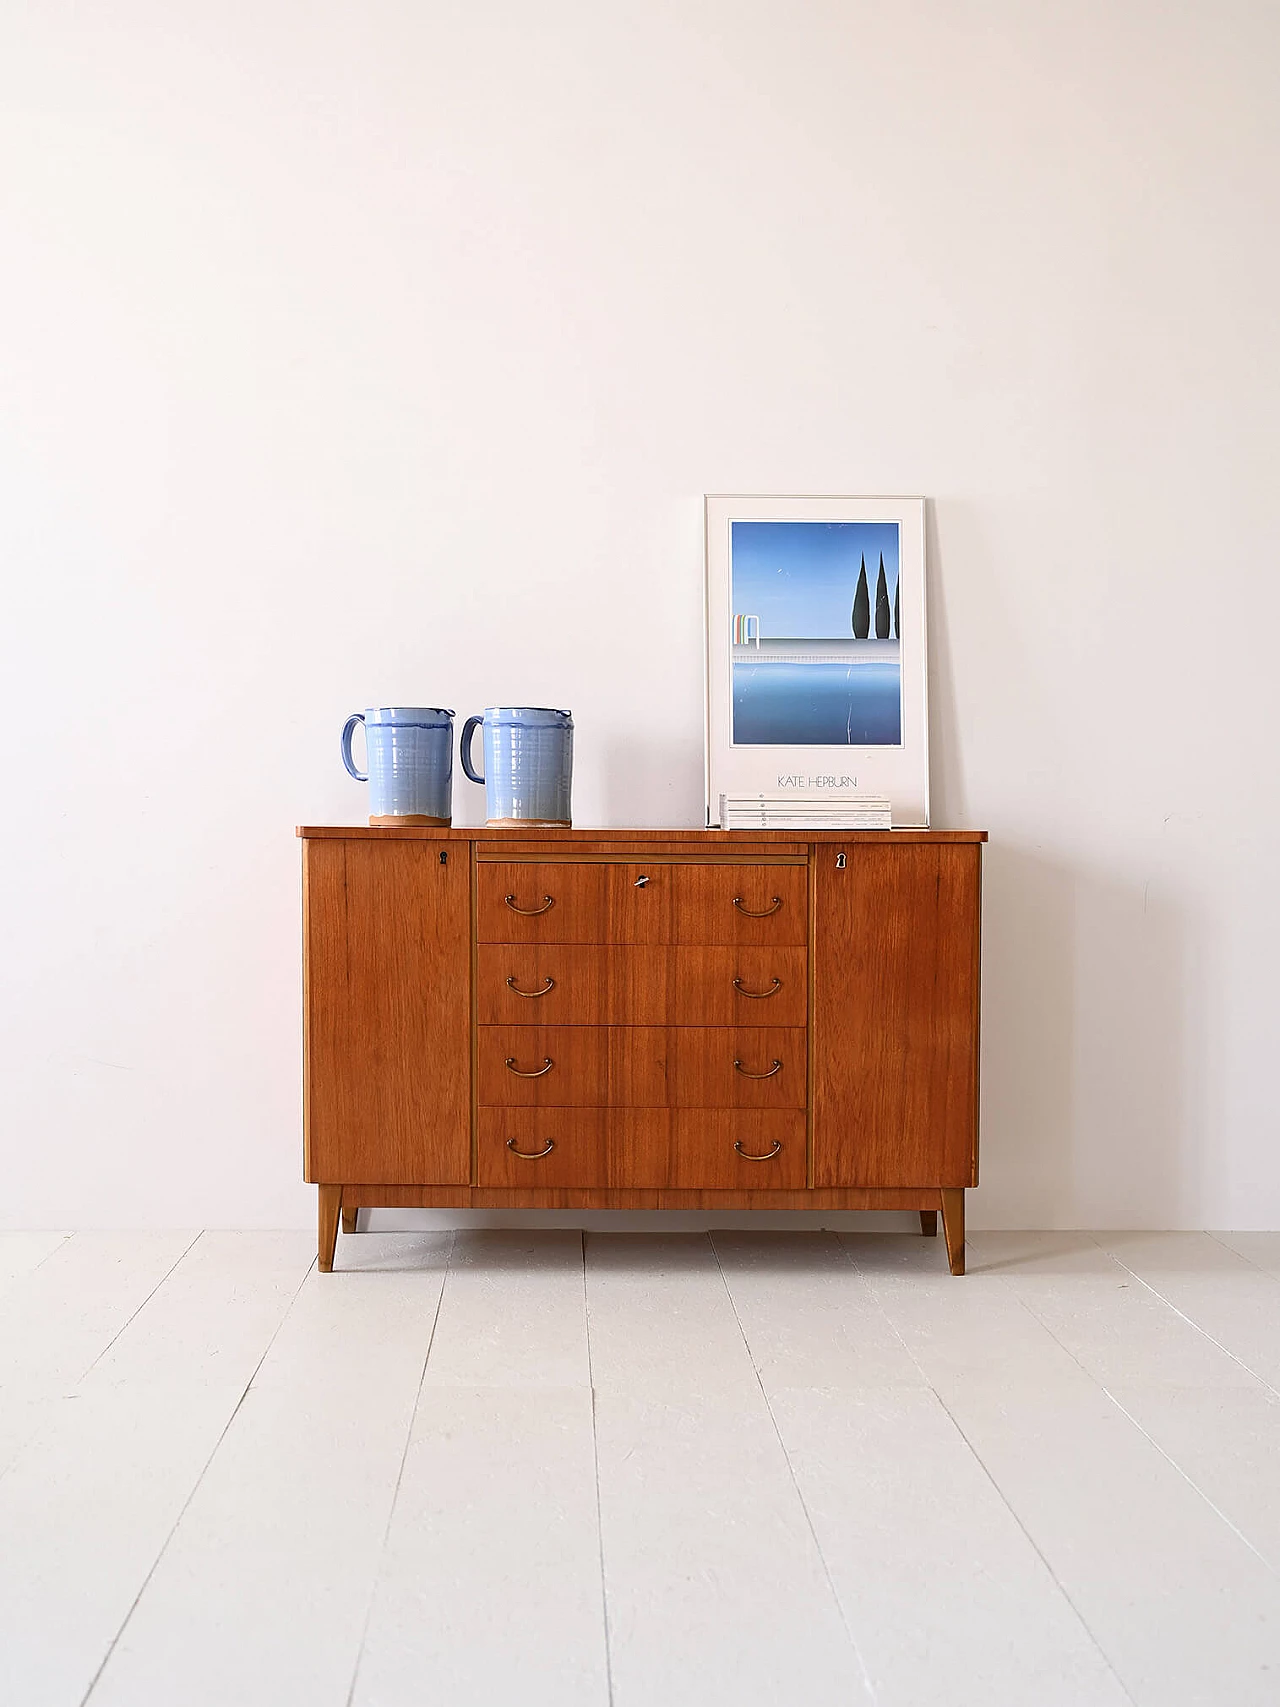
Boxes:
[304,838,471,1185]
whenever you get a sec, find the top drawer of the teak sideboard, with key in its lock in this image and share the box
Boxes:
[476,859,809,946]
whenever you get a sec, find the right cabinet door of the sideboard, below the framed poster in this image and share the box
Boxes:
[812,842,980,1186]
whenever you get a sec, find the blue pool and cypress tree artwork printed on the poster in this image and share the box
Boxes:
[729,522,903,746]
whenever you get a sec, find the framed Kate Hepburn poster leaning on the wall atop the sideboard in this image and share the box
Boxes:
[707,497,928,826]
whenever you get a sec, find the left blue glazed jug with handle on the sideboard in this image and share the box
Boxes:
[341,705,454,826]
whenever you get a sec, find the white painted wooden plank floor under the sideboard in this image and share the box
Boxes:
[0,1232,1280,1707]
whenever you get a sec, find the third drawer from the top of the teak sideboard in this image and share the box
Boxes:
[476,1026,807,1108]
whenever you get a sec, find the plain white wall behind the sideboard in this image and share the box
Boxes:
[0,0,1280,1227]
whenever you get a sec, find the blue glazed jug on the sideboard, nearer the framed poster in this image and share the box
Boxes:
[463,705,573,828]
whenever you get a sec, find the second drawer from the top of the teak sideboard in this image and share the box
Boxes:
[476,942,809,1026]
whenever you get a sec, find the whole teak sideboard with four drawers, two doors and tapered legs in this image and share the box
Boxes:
[299,828,986,1273]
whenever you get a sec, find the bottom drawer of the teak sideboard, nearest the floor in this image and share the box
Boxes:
[476,1108,807,1191]
